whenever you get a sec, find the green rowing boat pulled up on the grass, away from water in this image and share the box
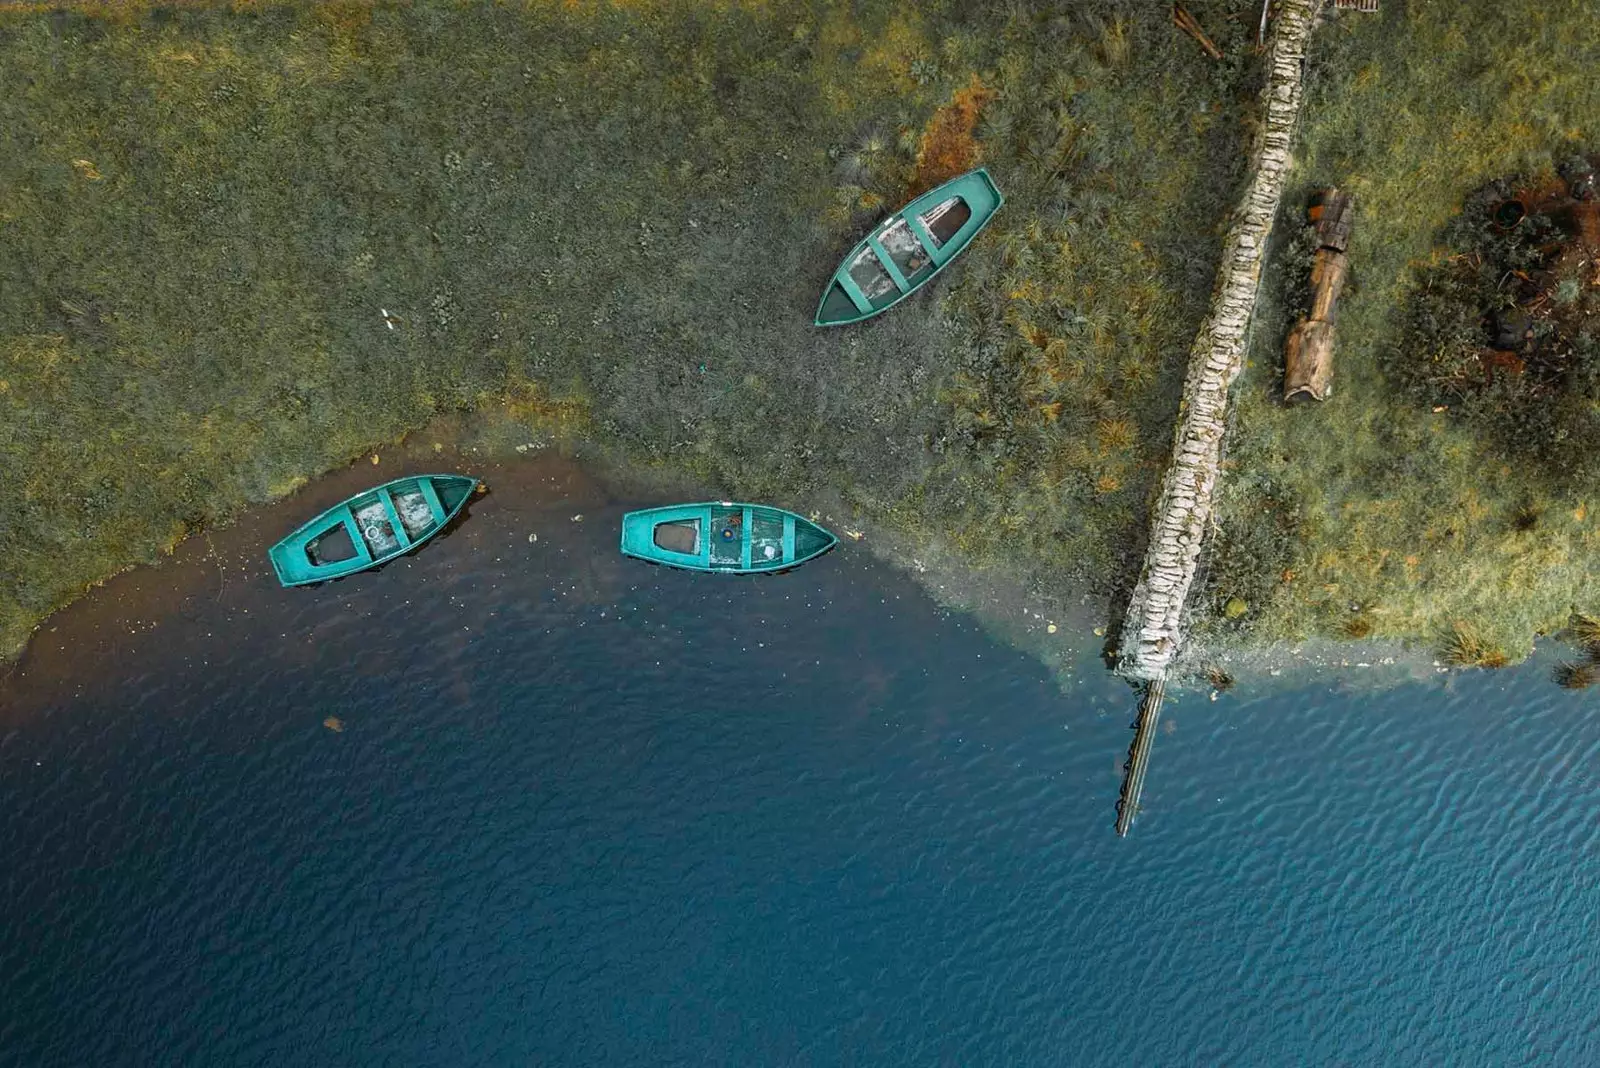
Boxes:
[816,168,1005,326]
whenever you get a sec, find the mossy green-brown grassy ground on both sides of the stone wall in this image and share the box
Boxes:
[0,0,1600,671]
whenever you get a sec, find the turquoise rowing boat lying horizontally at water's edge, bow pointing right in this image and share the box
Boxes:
[622,500,838,576]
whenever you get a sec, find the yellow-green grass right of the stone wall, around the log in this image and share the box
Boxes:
[1203,2,1600,664]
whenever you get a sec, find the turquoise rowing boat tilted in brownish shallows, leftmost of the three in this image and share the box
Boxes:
[267,475,478,585]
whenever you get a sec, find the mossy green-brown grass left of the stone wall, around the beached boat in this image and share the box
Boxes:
[0,0,1273,654]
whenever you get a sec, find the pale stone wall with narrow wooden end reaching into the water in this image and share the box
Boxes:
[1117,0,1322,835]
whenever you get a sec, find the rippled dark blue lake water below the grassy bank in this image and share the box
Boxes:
[0,470,1600,1068]
